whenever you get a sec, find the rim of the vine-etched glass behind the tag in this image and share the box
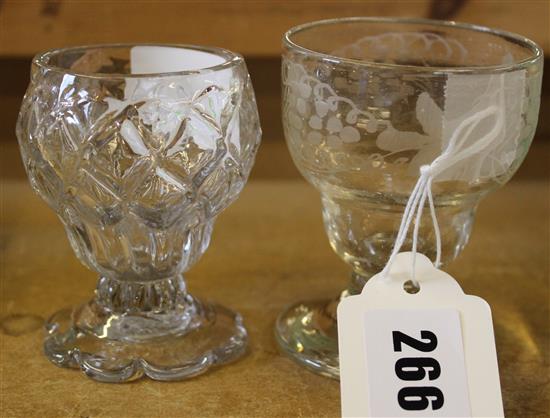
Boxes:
[283,16,544,74]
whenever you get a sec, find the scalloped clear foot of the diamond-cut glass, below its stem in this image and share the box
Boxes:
[44,299,247,382]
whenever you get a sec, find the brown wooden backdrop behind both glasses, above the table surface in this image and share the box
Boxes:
[0,0,550,178]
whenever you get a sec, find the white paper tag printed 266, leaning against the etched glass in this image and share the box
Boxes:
[338,253,504,417]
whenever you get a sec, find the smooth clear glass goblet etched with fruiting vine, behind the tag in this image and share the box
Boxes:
[275,18,543,378]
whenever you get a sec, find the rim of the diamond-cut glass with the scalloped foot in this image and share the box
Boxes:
[32,43,244,79]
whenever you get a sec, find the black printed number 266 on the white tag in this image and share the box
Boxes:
[392,330,444,411]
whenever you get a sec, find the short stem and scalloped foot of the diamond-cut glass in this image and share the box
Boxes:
[44,275,247,382]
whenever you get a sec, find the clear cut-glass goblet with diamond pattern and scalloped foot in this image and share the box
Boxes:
[17,45,261,382]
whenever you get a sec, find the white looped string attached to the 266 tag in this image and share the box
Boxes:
[381,80,505,284]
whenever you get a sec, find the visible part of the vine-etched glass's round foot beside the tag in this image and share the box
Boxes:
[275,291,347,379]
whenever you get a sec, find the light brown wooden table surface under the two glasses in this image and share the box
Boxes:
[0,175,550,418]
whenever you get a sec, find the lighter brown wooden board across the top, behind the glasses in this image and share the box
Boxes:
[0,0,550,56]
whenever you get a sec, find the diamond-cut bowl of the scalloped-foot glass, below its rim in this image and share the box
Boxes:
[17,68,261,280]
